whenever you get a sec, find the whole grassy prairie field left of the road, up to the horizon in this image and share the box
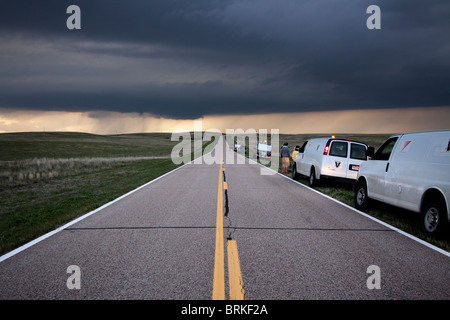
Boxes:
[0,132,211,254]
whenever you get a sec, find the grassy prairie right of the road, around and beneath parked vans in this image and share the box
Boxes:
[229,134,450,251]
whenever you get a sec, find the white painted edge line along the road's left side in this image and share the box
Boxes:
[0,159,195,262]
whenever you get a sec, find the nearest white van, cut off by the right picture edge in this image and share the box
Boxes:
[355,130,450,235]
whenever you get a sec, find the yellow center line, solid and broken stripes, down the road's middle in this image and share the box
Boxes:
[212,155,244,300]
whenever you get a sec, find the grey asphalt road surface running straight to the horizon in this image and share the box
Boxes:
[0,139,450,300]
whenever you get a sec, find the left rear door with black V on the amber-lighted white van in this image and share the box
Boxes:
[321,141,349,178]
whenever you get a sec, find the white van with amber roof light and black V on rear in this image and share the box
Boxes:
[292,138,373,187]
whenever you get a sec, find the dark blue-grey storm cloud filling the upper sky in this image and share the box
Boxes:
[0,0,450,118]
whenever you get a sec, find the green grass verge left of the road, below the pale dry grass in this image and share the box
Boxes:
[0,159,177,253]
